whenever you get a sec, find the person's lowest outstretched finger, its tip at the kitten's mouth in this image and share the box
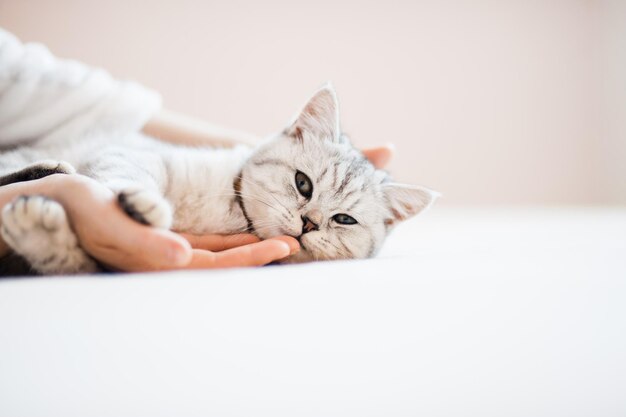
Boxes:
[185,239,291,269]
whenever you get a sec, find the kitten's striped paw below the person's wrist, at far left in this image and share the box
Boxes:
[0,195,98,274]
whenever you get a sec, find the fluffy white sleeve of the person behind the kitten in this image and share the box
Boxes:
[0,28,161,147]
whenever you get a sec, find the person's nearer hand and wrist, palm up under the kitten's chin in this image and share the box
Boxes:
[0,175,298,271]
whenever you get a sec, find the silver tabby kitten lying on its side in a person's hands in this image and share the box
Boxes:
[0,86,437,274]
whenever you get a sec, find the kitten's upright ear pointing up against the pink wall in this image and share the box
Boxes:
[285,83,341,142]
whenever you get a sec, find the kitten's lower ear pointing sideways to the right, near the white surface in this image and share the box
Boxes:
[383,182,440,226]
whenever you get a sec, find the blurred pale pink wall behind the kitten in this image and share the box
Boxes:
[0,0,626,205]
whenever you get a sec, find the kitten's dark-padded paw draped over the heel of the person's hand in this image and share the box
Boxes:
[117,188,172,229]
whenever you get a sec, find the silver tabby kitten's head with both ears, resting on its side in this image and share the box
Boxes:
[240,85,437,262]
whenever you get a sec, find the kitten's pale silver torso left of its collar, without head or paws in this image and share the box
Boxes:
[0,133,253,234]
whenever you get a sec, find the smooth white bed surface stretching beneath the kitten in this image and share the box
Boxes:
[0,208,626,417]
